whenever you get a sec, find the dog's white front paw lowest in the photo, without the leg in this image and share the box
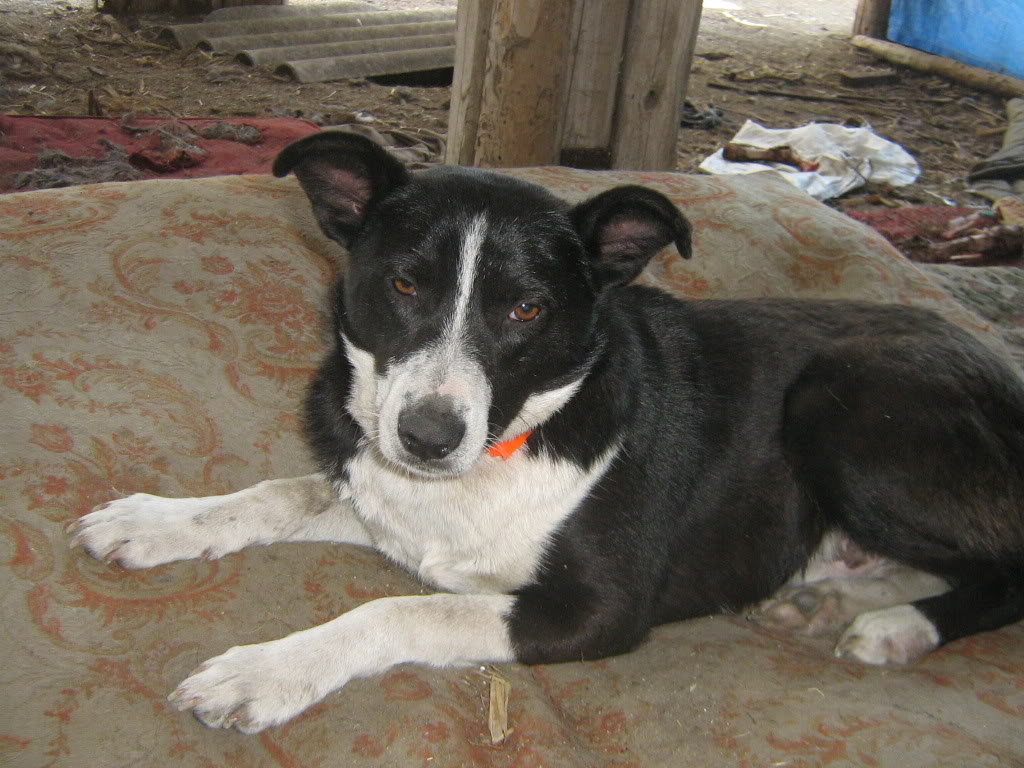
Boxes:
[168,638,332,733]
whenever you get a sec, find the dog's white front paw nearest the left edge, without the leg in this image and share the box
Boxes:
[68,494,237,568]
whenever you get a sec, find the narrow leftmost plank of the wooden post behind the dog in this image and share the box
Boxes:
[444,0,495,165]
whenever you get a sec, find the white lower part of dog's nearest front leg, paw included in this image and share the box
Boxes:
[170,594,514,733]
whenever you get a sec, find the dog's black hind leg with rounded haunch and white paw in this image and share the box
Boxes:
[784,333,1024,664]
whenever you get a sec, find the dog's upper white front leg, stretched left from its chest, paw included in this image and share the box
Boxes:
[69,474,371,568]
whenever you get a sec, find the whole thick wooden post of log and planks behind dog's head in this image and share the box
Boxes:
[446,0,701,170]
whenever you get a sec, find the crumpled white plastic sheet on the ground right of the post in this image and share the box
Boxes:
[700,120,921,200]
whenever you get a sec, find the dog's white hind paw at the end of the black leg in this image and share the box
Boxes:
[836,605,939,666]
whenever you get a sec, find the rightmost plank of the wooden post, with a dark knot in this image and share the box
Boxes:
[611,0,701,170]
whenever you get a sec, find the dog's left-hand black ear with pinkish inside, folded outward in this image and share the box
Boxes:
[273,131,409,246]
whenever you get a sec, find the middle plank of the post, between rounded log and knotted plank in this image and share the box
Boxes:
[562,0,631,151]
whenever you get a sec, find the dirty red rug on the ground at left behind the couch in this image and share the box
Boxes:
[0,116,319,193]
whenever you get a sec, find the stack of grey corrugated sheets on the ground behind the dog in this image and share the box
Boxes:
[161,2,456,83]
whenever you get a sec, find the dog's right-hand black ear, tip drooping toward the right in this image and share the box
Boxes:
[570,185,690,288]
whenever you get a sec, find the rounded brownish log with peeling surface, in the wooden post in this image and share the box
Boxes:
[474,0,575,168]
